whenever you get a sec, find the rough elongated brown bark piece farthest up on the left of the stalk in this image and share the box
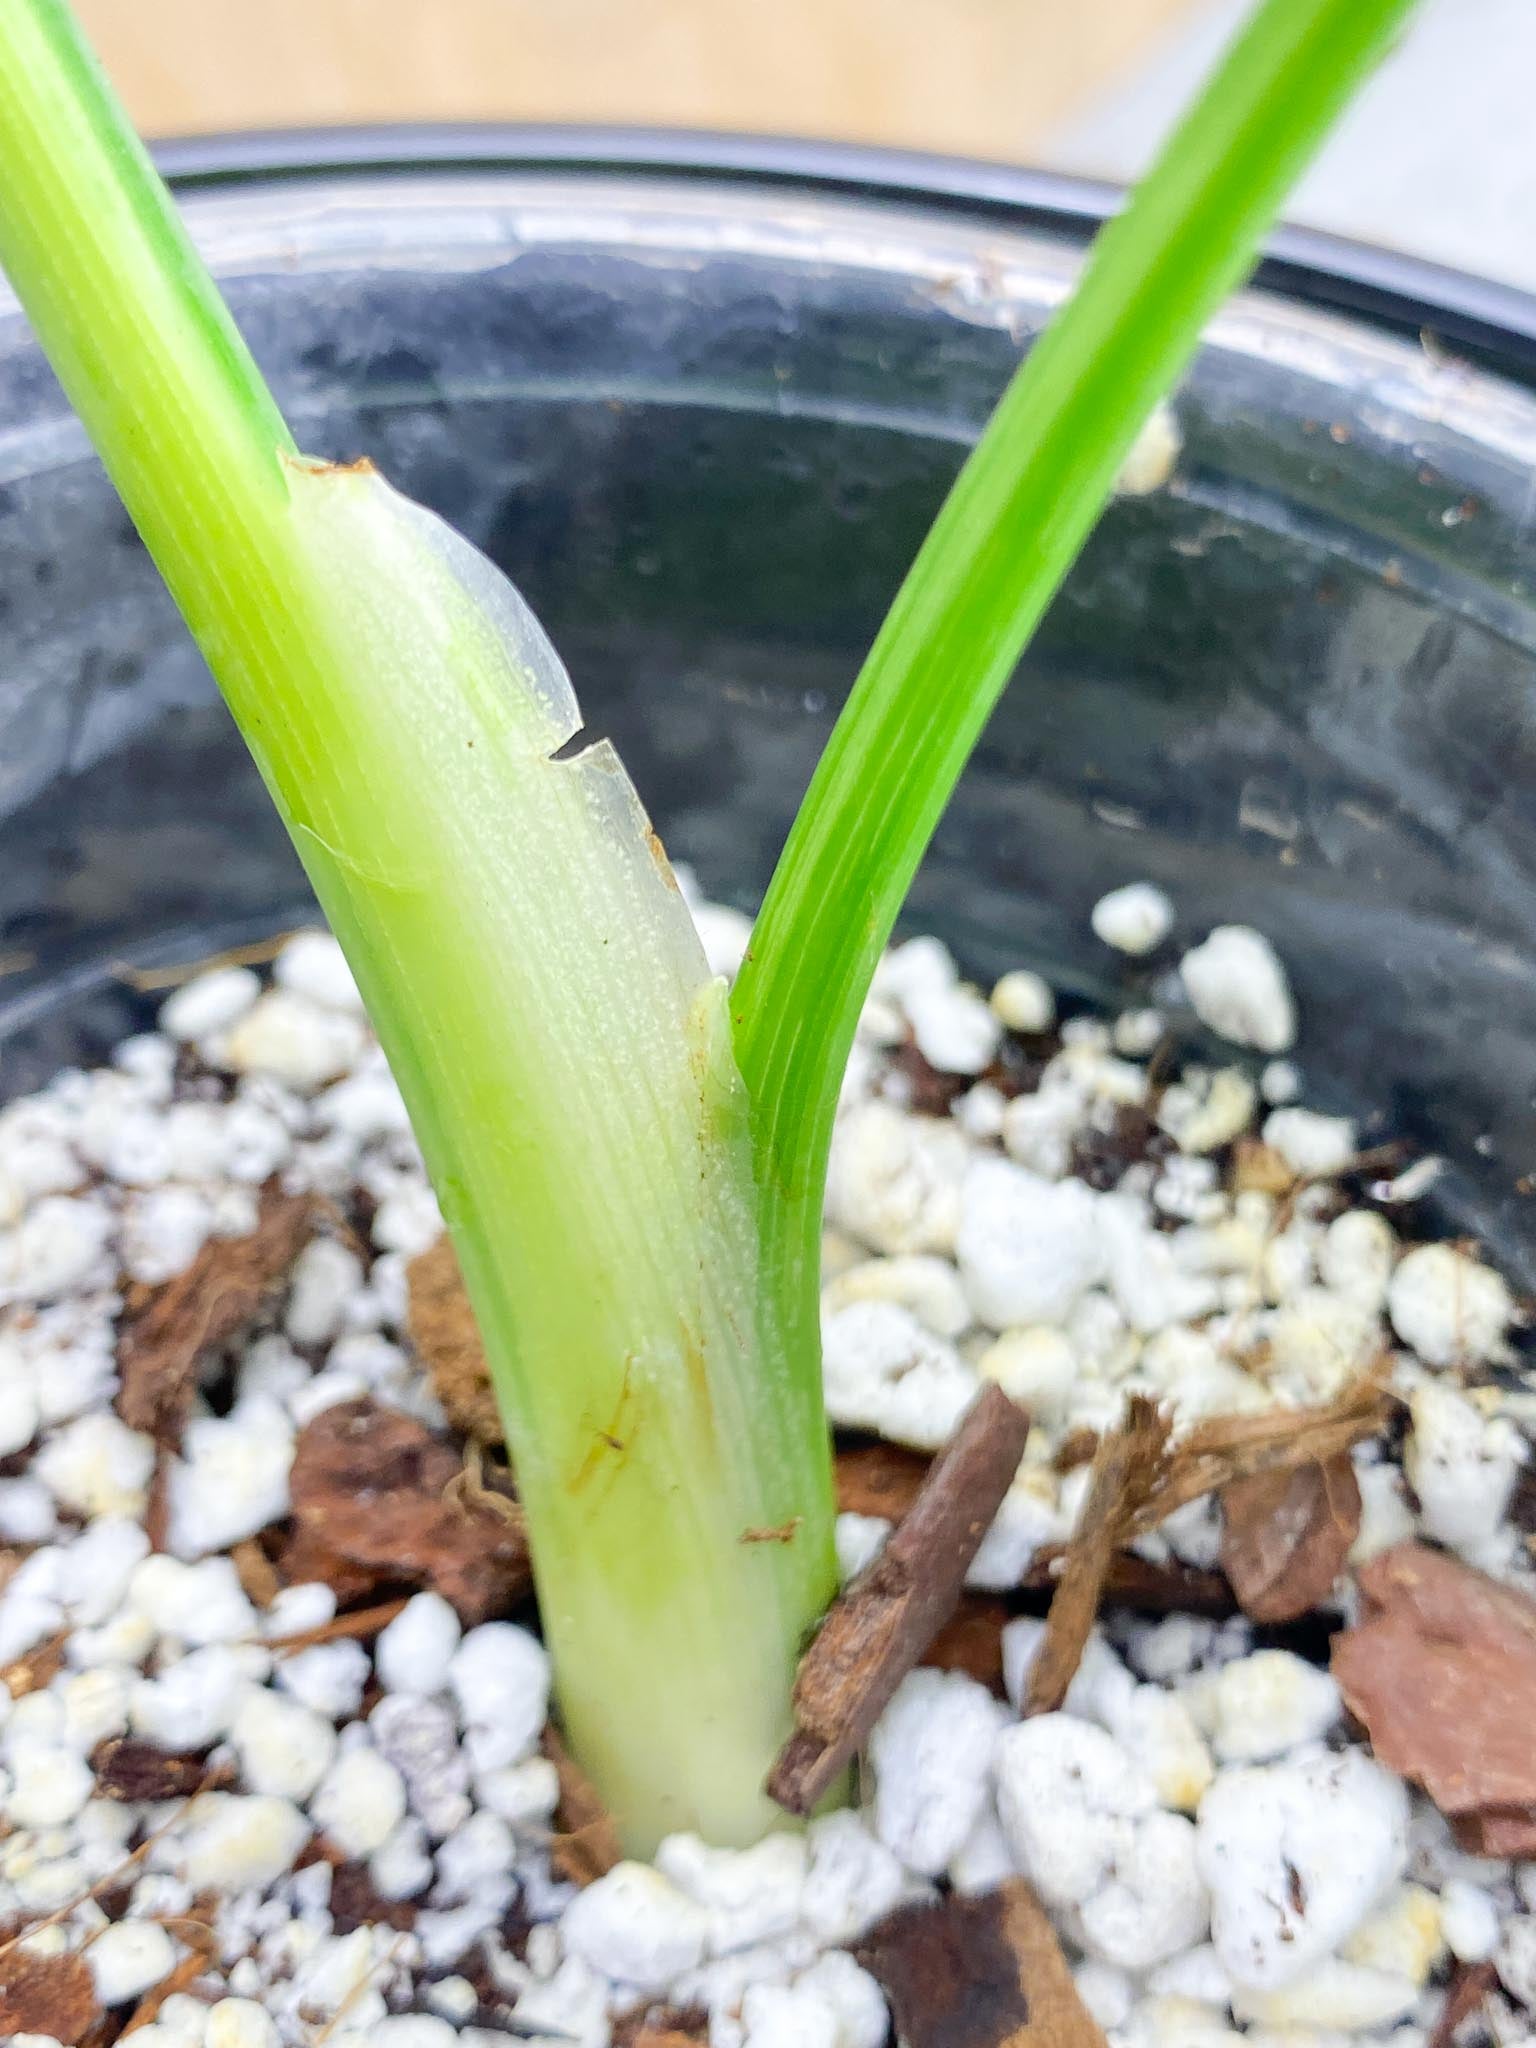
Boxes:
[117,1182,313,1448]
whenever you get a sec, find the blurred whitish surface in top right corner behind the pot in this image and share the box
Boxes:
[1044,0,1536,289]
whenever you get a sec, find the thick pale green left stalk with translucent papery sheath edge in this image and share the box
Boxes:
[0,0,836,1849]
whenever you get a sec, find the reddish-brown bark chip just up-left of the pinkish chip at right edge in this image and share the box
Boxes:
[1221,1450,1360,1622]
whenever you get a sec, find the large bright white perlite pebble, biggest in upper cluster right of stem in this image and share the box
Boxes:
[954,1159,1104,1329]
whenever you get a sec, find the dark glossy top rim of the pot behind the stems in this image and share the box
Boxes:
[154,121,1536,385]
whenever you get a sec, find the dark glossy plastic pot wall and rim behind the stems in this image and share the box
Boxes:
[0,129,1536,1276]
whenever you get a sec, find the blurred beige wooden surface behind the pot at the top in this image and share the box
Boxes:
[75,0,1198,158]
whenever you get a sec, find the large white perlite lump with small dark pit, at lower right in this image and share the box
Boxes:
[1196,1749,1409,1991]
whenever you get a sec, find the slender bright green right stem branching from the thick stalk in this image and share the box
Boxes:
[731,0,1413,1382]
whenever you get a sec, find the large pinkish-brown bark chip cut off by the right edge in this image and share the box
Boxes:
[1333,1542,1536,1826]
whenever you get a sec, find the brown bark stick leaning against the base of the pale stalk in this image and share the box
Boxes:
[768,1386,1030,1815]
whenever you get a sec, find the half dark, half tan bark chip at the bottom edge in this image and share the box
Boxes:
[854,1878,1106,2048]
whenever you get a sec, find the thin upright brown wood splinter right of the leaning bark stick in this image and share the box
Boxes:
[1024,1395,1169,1716]
